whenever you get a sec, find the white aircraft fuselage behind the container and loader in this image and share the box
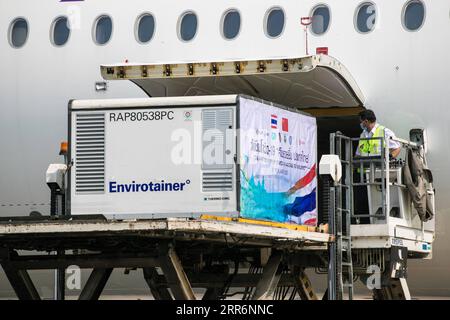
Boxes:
[0,0,450,295]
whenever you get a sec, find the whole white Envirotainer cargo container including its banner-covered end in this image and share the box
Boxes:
[67,95,317,225]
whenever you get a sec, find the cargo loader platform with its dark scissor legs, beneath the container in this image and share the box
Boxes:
[0,216,333,300]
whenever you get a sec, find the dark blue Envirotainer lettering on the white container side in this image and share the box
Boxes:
[108,180,191,193]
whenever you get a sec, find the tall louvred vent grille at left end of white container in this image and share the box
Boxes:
[75,113,105,194]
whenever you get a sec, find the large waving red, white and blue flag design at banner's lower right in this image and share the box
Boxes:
[284,165,317,226]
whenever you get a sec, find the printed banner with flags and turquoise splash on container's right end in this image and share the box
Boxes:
[240,98,317,226]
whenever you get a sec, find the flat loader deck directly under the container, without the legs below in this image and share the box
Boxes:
[0,217,332,251]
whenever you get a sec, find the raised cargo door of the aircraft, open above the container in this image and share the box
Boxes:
[101,55,364,109]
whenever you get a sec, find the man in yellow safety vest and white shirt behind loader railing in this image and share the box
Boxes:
[356,109,401,158]
